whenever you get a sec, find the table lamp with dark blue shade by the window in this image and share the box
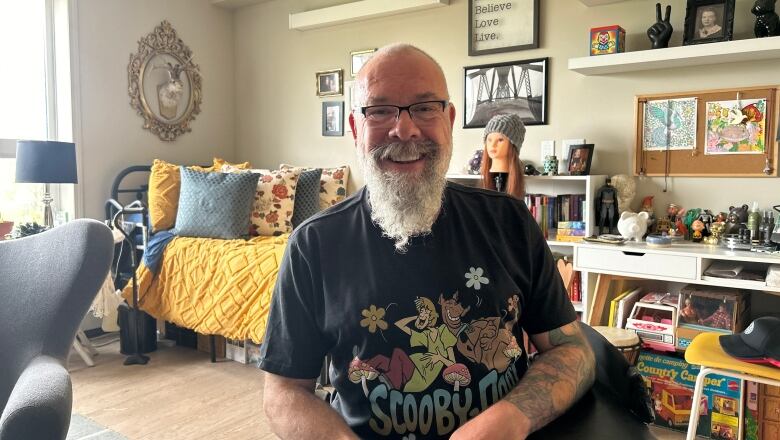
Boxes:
[16,141,78,228]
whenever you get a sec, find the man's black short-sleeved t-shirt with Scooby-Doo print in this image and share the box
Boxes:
[260,183,576,439]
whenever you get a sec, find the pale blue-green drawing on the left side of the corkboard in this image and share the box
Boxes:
[642,98,698,151]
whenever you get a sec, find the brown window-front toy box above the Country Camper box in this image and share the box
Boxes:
[677,284,750,349]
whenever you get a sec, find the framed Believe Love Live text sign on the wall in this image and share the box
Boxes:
[468,0,539,56]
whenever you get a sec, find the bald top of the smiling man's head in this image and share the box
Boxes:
[355,43,449,106]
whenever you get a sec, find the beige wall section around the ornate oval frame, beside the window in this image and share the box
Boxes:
[74,0,235,219]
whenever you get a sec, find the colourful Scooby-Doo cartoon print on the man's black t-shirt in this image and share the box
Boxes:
[347,267,526,438]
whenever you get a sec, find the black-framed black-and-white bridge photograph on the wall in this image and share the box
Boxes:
[463,58,549,128]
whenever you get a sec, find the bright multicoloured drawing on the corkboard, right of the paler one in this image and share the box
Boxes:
[704,99,766,154]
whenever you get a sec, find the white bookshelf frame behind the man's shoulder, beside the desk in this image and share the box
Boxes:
[447,174,607,317]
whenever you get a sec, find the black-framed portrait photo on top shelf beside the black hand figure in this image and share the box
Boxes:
[683,0,734,46]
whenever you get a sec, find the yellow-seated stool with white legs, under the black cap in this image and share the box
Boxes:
[685,333,780,440]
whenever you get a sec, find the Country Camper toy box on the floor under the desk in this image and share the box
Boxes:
[637,351,741,439]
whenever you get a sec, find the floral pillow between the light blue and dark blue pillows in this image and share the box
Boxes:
[249,168,301,236]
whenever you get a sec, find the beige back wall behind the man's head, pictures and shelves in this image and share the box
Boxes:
[234,0,780,215]
